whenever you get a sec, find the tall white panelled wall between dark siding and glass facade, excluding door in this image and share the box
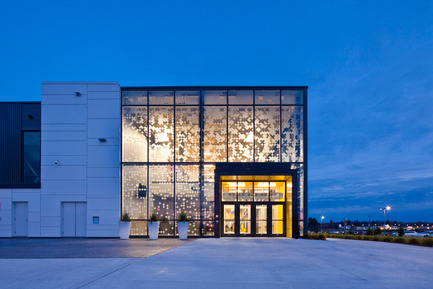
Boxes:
[40,82,120,237]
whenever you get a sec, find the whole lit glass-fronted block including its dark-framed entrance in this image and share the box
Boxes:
[120,86,307,238]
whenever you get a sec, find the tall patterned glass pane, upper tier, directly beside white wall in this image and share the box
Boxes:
[122,107,147,162]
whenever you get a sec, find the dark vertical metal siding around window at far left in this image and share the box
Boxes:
[0,102,41,188]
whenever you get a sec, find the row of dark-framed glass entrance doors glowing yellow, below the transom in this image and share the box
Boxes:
[222,202,286,237]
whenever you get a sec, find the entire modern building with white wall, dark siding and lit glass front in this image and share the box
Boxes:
[0,82,307,238]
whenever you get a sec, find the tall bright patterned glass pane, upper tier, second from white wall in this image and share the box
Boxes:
[149,106,174,162]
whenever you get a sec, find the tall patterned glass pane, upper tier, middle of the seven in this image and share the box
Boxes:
[203,106,227,162]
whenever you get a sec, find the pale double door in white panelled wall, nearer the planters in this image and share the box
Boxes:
[62,202,87,237]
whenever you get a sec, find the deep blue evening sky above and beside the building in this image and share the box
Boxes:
[0,0,433,221]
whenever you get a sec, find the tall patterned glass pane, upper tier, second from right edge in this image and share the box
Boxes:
[254,106,280,162]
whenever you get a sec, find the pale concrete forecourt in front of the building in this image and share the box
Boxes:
[0,238,433,289]
